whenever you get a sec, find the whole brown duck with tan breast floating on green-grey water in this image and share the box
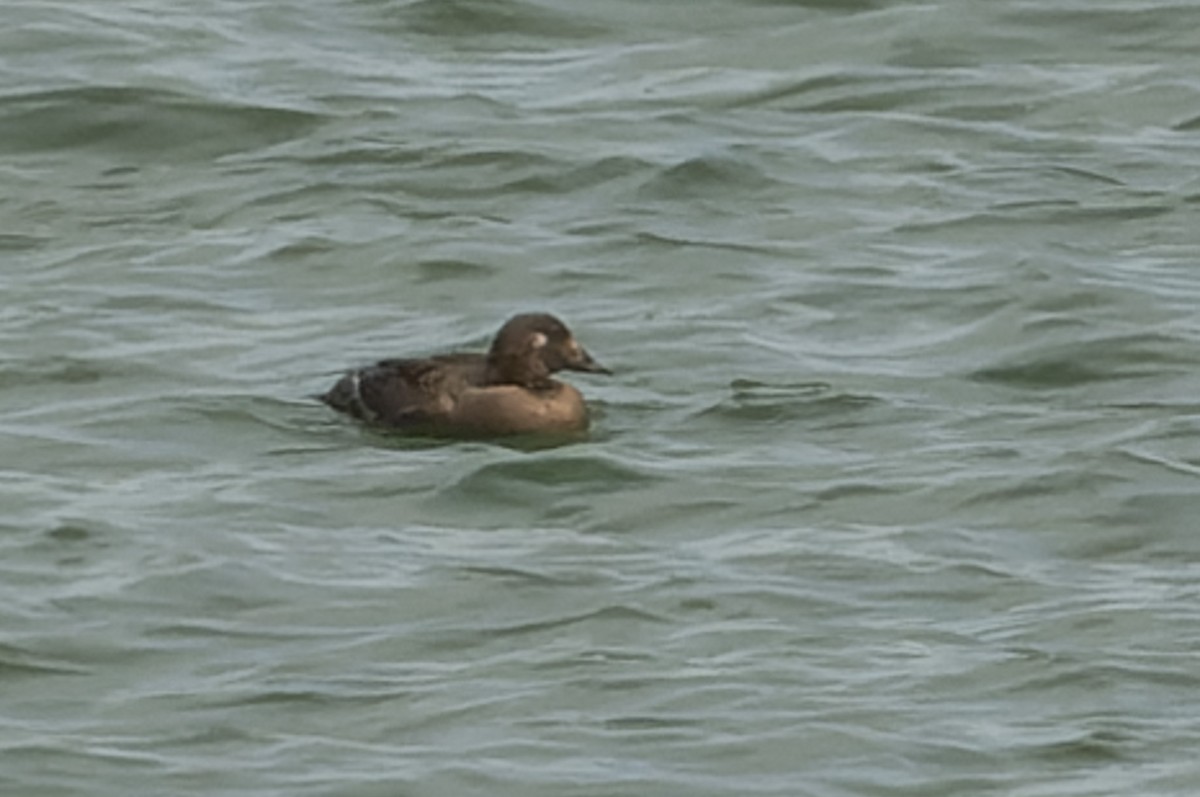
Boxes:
[318,312,612,437]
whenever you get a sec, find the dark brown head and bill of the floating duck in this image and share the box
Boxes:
[487,313,612,388]
